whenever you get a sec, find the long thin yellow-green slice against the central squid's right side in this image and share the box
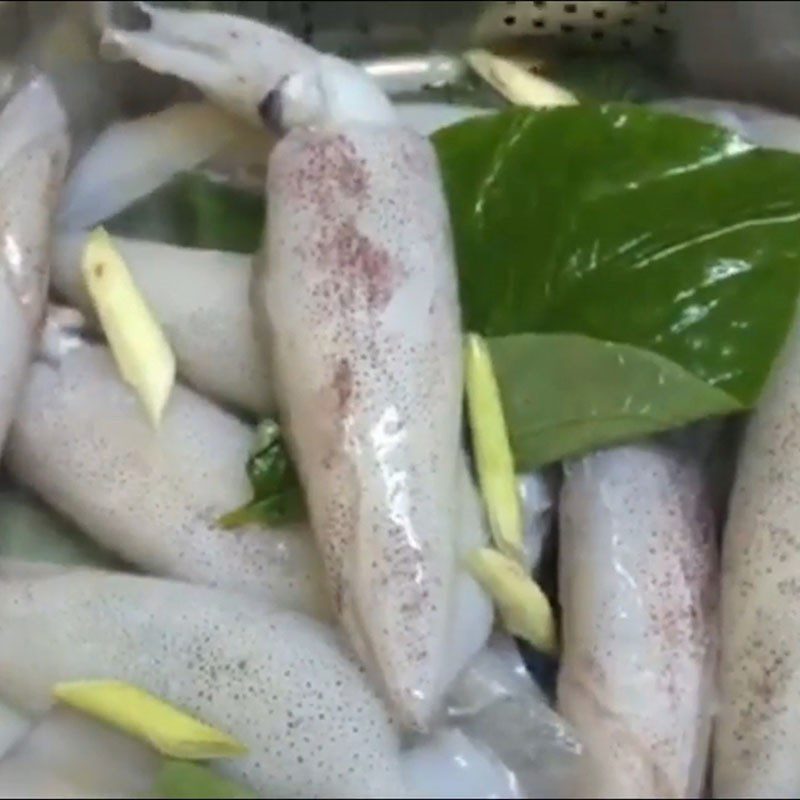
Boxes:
[465,334,523,561]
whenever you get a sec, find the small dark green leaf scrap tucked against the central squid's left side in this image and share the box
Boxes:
[219,419,305,529]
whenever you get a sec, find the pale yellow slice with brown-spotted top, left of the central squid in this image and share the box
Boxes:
[82,228,175,426]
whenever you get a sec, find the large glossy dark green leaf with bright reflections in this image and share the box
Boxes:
[434,105,800,406]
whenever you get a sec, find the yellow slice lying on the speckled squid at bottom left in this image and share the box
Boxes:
[53,680,247,761]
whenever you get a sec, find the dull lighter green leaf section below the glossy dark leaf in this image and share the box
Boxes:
[489,333,742,470]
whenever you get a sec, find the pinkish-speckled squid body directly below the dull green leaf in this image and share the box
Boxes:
[558,442,717,798]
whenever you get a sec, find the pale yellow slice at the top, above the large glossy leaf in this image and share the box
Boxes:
[464,50,578,108]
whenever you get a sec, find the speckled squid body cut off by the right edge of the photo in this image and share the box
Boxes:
[714,327,800,797]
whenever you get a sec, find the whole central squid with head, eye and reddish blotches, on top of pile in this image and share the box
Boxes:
[103,4,491,728]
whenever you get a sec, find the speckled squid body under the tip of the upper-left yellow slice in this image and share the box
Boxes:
[7,314,329,614]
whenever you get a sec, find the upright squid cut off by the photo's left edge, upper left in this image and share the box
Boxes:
[0,77,69,450]
